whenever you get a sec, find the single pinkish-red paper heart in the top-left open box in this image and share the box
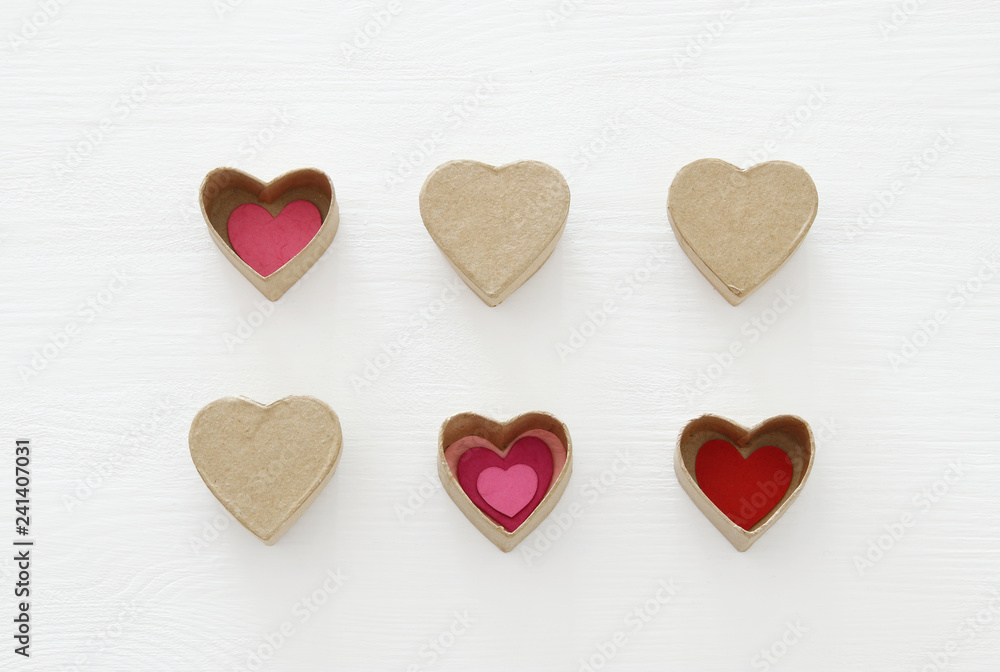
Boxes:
[226,200,323,277]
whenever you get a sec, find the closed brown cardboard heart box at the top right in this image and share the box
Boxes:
[667,159,819,306]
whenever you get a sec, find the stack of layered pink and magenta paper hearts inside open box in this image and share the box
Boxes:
[454,431,566,532]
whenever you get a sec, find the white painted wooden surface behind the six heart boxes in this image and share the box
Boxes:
[0,0,1000,672]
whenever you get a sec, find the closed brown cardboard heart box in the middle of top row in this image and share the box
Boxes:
[420,161,569,306]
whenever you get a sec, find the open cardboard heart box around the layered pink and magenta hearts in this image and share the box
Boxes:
[438,412,573,553]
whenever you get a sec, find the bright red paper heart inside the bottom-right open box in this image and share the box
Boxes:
[694,439,792,530]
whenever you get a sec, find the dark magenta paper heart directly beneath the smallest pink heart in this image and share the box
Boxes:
[456,436,562,532]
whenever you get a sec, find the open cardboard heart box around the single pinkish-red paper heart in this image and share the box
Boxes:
[199,168,340,301]
